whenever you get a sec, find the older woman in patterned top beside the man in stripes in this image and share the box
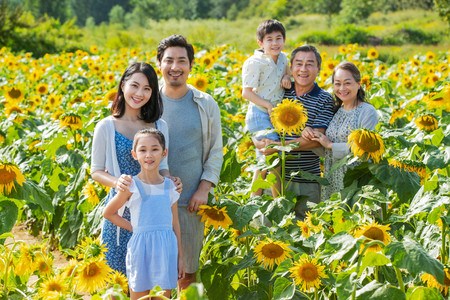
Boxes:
[312,61,378,200]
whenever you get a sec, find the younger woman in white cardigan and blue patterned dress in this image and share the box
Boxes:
[91,62,181,274]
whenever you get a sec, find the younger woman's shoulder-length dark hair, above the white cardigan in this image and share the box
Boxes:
[111,62,163,123]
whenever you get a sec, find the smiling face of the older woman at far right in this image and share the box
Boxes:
[333,69,361,107]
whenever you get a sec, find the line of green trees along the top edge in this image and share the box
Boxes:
[3,0,444,26]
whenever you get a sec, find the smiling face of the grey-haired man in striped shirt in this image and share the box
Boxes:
[291,51,320,90]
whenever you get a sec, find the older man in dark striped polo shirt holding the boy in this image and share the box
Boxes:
[257,45,334,219]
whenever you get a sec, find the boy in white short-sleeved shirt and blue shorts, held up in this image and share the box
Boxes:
[242,20,291,197]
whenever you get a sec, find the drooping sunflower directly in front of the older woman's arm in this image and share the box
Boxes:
[347,128,385,163]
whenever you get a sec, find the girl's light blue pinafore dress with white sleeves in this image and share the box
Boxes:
[126,176,179,292]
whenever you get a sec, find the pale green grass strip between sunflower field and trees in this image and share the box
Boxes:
[79,10,450,59]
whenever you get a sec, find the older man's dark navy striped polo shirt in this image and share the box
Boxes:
[284,83,334,183]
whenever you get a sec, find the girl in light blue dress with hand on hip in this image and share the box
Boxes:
[103,129,184,299]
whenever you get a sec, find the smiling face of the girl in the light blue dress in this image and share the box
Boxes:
[131,134,167,172]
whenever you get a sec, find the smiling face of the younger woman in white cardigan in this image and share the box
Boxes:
[122,73,152,111]
